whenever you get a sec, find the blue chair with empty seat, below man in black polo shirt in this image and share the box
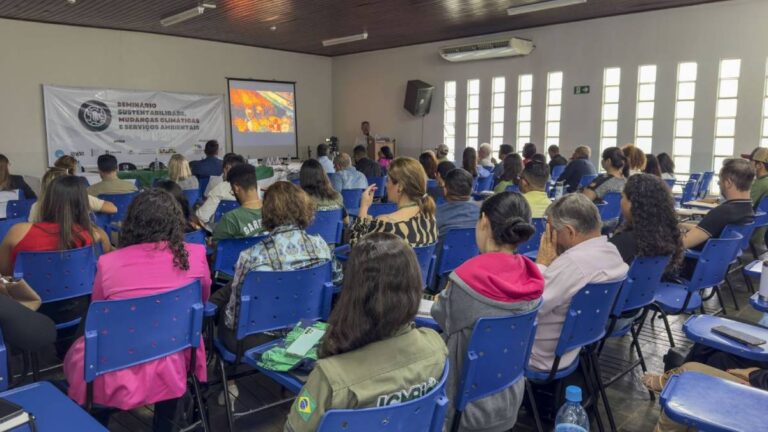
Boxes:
[654,233,742,347]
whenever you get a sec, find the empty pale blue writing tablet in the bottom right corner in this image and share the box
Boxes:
[660,371,768,432]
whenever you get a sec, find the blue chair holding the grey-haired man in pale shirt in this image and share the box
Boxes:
[525,279,624,431]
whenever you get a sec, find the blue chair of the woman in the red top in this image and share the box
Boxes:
[13,246,96,329]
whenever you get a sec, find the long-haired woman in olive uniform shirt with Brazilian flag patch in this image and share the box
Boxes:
[284,233,454,432]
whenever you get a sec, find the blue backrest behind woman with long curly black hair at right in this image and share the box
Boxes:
[611,256,671,317]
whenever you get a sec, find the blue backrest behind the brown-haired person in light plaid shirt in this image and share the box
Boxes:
[236,261,333,340]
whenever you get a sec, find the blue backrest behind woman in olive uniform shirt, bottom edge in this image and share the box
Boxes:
[317,361,449,432]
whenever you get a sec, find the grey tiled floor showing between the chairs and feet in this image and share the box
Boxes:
[24,266,760,432]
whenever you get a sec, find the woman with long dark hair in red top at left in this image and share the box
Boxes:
[0,176,112,323]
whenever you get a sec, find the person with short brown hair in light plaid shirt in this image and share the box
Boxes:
[211,181,331,352]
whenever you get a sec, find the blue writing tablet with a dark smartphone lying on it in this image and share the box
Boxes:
[683,315,768,362]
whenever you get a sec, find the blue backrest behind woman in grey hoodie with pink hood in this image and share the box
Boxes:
[451,303,541,411]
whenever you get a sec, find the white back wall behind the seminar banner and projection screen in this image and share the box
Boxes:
[0,19,332,176]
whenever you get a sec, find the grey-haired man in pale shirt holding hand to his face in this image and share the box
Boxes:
[529,194,629,371]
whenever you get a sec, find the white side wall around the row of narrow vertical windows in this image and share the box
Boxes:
[333,0,768,174]
